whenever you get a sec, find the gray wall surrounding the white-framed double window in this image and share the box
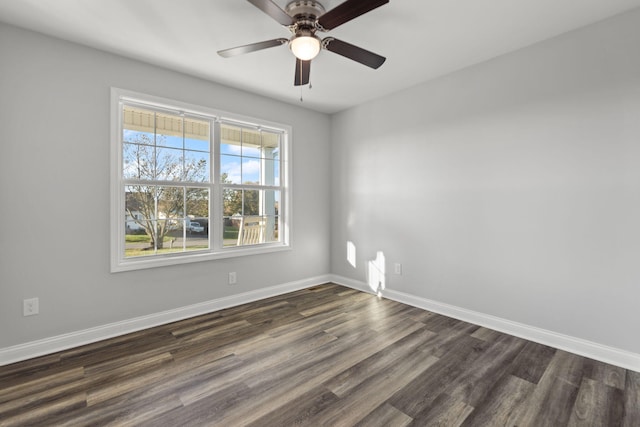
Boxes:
[0,24,330,348]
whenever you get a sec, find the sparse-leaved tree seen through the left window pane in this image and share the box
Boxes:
[123,132,209,249]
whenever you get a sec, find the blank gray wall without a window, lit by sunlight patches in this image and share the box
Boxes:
[331,11,640,353]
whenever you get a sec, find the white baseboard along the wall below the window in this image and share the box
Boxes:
[0,275,331,366]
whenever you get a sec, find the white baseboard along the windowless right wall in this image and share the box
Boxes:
[331,275,640,372]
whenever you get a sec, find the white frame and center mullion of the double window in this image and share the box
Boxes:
[111,87,292,273]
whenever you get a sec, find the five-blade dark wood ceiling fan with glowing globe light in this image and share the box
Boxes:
[218,0,389,86]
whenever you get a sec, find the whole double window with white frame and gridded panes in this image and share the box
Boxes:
[111,89,290,271]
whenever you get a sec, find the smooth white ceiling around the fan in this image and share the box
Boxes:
[0,0,640,113]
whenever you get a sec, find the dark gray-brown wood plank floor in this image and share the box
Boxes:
[0,284,640,427]
